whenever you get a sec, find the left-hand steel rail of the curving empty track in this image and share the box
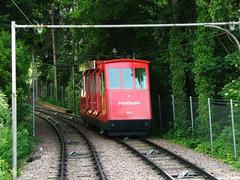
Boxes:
[36,114,66,180]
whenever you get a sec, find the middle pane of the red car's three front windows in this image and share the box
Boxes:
[122,68,134,89]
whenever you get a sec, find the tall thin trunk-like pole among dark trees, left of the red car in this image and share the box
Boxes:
[52,3,58,101]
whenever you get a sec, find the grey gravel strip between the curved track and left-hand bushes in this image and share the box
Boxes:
[18,118,60,180]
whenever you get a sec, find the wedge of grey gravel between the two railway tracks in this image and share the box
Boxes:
[83,131,163,180]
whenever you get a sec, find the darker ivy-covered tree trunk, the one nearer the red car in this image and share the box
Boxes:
[168,27,187,134]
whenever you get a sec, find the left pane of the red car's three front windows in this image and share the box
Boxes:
[108,68,120,89]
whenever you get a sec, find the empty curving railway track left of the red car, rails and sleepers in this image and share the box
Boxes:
[37,109,106,180]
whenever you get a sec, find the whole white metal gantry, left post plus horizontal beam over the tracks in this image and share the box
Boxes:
[11,21,240,180]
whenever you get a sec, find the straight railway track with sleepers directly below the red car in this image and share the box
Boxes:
[115,138,217,180]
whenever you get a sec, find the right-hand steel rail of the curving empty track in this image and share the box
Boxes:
[36,109,107,180]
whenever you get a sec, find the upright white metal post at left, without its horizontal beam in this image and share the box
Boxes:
[11,21,17,180]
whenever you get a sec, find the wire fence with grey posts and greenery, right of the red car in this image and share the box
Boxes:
[158,96,240,159]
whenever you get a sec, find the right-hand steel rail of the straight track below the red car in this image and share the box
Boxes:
[140,139,217,180]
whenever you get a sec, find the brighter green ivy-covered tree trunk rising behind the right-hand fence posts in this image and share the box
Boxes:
[193,0,215,137]
